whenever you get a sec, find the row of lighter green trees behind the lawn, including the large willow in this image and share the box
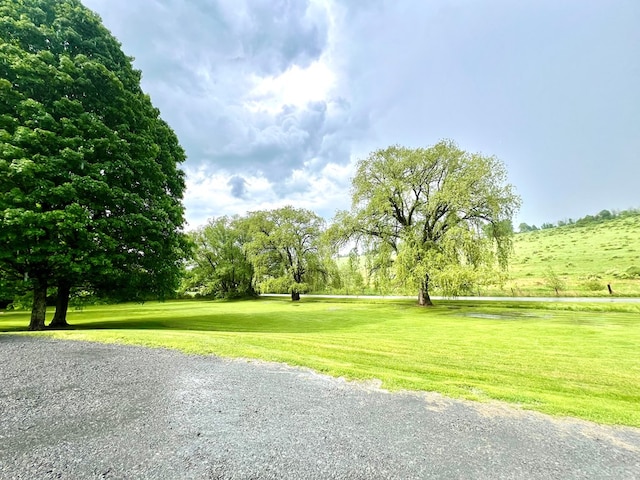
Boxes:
[183,141,519,305]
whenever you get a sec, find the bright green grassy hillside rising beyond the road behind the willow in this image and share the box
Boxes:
[500,213,640,296]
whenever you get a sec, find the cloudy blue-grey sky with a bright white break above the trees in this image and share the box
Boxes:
[82,0,640,229]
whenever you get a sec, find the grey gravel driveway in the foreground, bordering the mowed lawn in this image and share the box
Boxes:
[0,335,640,479]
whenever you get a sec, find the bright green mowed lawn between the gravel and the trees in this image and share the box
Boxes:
[0,298,640,427]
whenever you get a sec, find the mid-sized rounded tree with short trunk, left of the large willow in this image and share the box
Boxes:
[245,206,328,301]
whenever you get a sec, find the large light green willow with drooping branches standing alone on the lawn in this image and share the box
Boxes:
[337,141,520,305]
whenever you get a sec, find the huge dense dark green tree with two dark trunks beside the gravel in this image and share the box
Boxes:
[0,0,186,329]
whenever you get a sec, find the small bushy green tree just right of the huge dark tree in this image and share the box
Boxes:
[183,217,255,298]
